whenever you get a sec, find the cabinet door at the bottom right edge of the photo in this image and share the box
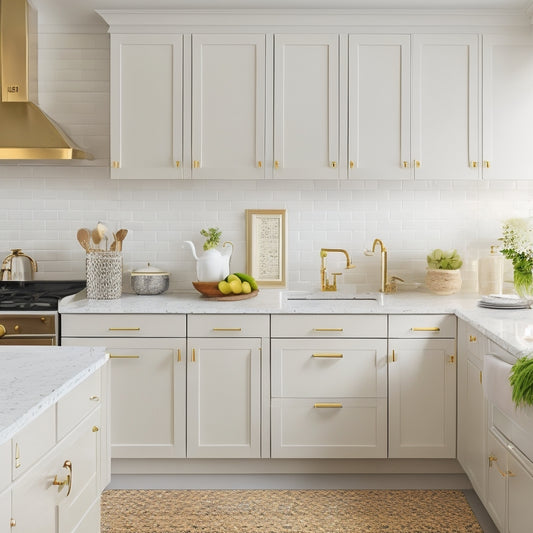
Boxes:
[507,448,533,533]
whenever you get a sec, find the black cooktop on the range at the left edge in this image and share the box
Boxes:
[0,280,86,311]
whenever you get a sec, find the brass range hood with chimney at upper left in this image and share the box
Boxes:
[0,0,92,160]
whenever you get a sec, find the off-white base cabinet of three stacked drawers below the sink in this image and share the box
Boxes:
[271,315,387,458]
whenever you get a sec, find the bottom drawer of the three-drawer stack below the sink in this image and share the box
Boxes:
[272,398,387,459]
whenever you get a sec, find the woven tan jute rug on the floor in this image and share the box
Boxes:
[101,490,483,533]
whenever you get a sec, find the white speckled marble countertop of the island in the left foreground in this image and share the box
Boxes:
[0,346,107,444]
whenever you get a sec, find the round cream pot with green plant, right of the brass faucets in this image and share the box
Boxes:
[426,248,463,295]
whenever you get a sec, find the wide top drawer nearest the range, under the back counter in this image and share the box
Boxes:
[61,314,186,337]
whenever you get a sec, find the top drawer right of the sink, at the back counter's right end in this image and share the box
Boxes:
[389,315,457,339]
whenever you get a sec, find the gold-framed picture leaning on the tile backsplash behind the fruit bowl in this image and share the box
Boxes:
[246,209,287,287]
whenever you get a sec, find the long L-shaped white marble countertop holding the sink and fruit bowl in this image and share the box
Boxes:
[59,288,533,357]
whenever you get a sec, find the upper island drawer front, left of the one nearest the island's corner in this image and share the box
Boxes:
[11,405,56,479]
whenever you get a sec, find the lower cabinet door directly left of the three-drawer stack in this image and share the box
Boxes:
[187,338,261,458]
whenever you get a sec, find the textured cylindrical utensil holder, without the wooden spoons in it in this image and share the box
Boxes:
[87,252,122,300]
